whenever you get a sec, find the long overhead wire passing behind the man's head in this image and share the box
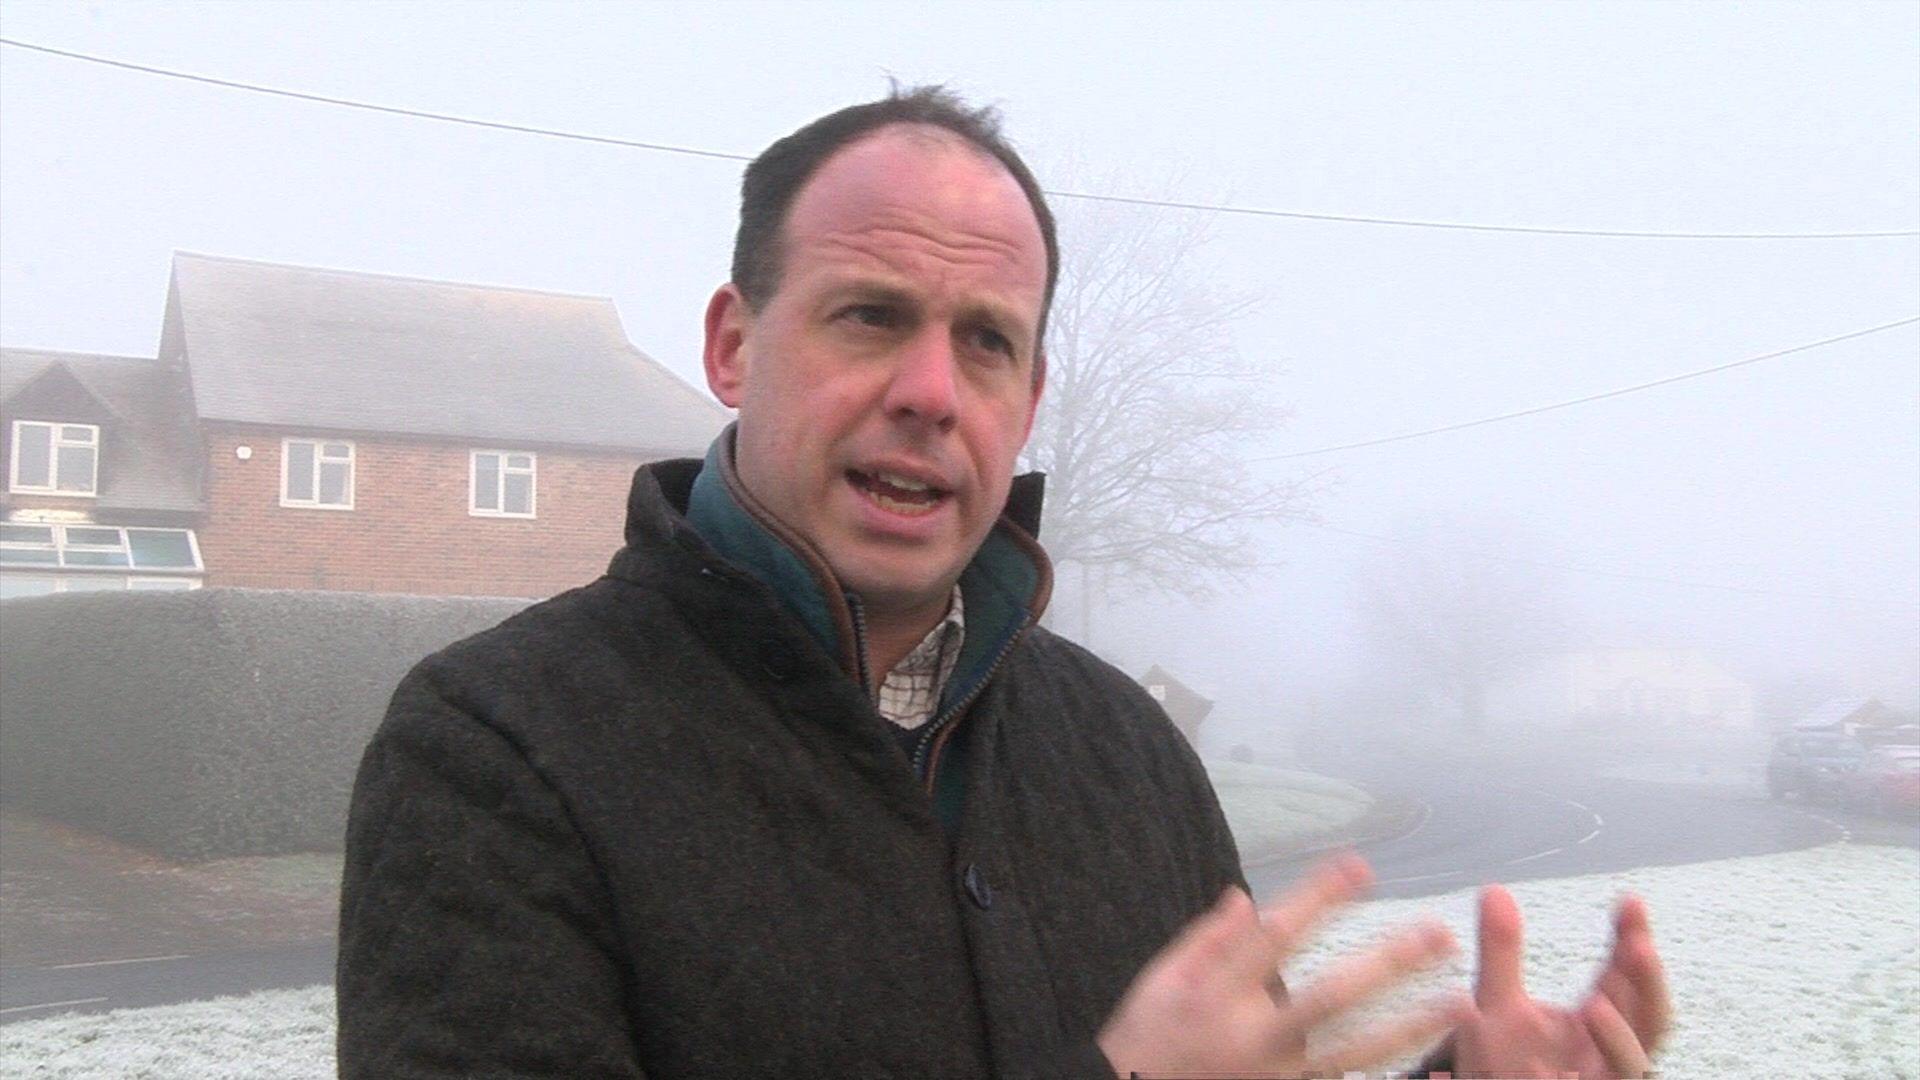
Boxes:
[0,38,1920,240]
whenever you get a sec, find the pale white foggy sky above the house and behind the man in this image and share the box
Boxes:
[0,0,1920,1060]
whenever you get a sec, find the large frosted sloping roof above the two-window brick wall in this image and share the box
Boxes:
[163,252,728,457]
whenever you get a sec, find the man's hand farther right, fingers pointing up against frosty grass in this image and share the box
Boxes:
[1452,886,1672,1078]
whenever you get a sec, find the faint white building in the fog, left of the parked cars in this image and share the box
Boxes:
[1488,648,1753,730]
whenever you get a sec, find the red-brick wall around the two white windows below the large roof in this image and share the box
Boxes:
[200,423,656,598]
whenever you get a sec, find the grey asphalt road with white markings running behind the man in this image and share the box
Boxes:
[0,749,1920,1022]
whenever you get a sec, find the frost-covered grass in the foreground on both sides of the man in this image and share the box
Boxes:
[0,844,1920,1080]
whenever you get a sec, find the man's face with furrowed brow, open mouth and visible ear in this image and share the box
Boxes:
[707,125,1046,613]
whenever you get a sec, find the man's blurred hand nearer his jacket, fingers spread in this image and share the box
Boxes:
[1098,855,1471,1076]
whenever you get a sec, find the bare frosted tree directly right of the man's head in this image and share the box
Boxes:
[1025,198,1309,596]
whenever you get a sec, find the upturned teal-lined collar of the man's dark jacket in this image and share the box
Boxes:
[675,425,1052,691]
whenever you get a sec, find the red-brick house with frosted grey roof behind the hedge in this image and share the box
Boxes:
[0,252,728,598]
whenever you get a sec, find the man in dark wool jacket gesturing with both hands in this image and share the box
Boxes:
[338,90,1665,1078]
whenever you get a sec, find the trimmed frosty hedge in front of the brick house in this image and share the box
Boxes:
[0,588,526,859]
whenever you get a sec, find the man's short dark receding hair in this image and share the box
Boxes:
[733,86,1060,361]
